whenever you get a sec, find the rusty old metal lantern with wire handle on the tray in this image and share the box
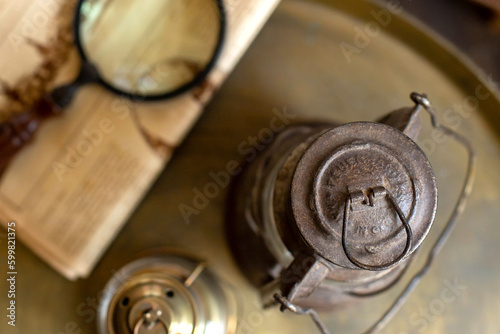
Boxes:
[227,93,474,333]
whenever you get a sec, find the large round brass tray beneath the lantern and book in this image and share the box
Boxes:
[0,0,500,334]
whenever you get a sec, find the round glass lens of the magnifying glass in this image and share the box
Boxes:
[77,0,222,97]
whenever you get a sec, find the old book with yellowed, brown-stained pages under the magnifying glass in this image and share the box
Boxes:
[0,0,279,280]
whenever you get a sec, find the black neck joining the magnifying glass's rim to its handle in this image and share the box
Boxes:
[50,61,99,108]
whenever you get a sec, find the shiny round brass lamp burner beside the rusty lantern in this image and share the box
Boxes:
[98,254,236,334]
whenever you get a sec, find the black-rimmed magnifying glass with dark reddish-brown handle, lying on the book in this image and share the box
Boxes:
[0,0,226,171]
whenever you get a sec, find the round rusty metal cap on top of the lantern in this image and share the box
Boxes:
[291,122,437,270]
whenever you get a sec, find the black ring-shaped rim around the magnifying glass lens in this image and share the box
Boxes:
[70,0,227,102]
